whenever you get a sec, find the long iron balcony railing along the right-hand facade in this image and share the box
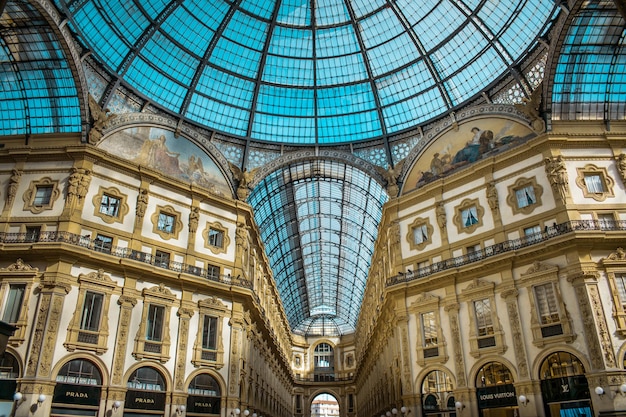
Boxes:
[387,220,626,287]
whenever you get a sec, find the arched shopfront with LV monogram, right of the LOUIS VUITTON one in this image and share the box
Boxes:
[539,352,594,417]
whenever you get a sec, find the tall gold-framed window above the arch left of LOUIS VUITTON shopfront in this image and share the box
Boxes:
[409,293,447,366]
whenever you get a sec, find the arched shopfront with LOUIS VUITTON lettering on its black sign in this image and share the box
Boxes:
[475,362,518,417]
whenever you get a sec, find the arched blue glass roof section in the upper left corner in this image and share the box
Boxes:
[0,1,82,135]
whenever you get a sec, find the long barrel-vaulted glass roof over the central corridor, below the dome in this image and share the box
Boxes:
[248,160,388,336]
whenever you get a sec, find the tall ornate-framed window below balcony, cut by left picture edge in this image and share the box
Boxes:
[0,259,36,346]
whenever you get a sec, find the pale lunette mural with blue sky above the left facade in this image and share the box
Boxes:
[98,126,232,196]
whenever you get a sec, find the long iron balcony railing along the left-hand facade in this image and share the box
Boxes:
[0,232,252,289]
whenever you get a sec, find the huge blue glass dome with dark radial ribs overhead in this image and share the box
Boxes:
[54,0,558,145]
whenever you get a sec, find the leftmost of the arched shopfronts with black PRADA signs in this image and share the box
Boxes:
[50,359,102,417]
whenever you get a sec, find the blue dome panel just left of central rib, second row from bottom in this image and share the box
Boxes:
[256,85,315,117]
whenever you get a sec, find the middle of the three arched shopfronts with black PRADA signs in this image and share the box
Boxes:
[124,366,166,417]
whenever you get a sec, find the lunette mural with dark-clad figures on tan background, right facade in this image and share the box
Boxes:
[403,118,537,192]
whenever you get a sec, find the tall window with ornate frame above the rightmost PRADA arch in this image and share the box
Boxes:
[192,297,227,369]
